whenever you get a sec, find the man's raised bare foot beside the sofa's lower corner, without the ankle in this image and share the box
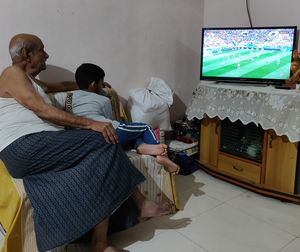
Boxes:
[140,200,172,218]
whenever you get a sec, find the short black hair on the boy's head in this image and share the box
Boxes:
[75,63,105,89]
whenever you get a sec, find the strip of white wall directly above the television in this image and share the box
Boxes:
[204,0,300,50]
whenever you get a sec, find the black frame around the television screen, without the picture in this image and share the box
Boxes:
[200,25,297,85]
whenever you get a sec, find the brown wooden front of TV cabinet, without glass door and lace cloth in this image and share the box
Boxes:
[199,117,300,203]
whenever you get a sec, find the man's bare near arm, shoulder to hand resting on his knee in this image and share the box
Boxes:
[2,66,117,143]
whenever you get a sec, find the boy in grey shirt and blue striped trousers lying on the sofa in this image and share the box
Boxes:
[72,63,180,174]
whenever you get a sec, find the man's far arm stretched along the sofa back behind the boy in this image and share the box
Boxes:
[34,79,79,93]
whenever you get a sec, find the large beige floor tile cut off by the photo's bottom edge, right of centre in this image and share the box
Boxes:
[177,203,295,252]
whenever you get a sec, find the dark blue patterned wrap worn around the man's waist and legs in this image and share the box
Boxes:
[0,129,145,251]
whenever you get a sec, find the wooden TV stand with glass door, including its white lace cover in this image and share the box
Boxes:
[186,83,300,203]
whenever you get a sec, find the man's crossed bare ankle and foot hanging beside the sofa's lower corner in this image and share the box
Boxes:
[132,189,172,218]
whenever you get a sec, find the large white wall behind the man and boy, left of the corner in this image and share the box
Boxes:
[0,0,204,121]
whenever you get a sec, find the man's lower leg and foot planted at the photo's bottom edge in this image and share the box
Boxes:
[91,219,128,252]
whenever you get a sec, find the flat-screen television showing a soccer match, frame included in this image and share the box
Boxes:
[200,26,297,85]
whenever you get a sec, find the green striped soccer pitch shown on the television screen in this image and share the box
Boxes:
[202,47,292,79]
